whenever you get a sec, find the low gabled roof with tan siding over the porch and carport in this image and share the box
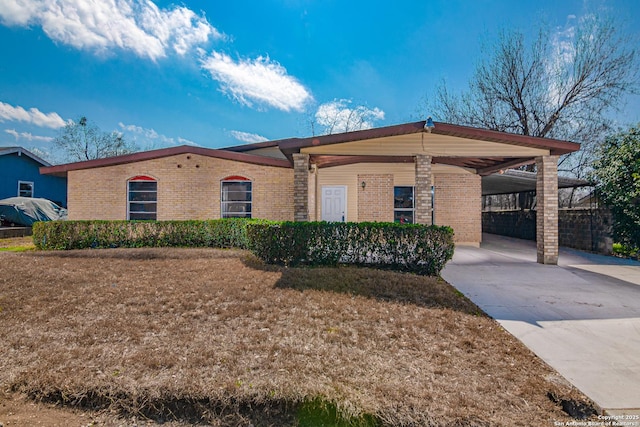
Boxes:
[225,121,580,175]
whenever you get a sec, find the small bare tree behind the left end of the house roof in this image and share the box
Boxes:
[53,117,136,162]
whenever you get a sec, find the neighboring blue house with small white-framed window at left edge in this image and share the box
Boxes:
[0,147,67,207]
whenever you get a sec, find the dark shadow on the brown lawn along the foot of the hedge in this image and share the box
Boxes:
[243,257,486,316]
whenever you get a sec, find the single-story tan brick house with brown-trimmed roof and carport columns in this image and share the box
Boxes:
[41,120,580,264]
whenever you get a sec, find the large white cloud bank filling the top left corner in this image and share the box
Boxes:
[0,0,223,60]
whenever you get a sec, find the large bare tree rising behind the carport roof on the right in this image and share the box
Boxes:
[422,15,638,177]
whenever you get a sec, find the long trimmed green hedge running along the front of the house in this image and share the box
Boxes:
[33,219,454,275]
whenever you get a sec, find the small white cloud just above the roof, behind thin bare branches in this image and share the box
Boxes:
[316,99,384,134]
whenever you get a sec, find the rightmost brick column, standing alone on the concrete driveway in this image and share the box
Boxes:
[536,156,558,265]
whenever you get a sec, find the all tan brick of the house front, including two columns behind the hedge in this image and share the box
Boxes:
[68,150,481,244]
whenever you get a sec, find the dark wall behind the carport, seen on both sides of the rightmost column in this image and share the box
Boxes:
[482,209,613,255]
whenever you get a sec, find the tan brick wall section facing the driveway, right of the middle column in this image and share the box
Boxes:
[434,174,482,245]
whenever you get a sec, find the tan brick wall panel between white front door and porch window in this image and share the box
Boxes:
[358,174,393,222]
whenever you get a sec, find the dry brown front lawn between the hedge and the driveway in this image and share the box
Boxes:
[0,249,588,426]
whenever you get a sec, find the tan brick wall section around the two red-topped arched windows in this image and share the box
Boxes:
[68,154,293,221]
